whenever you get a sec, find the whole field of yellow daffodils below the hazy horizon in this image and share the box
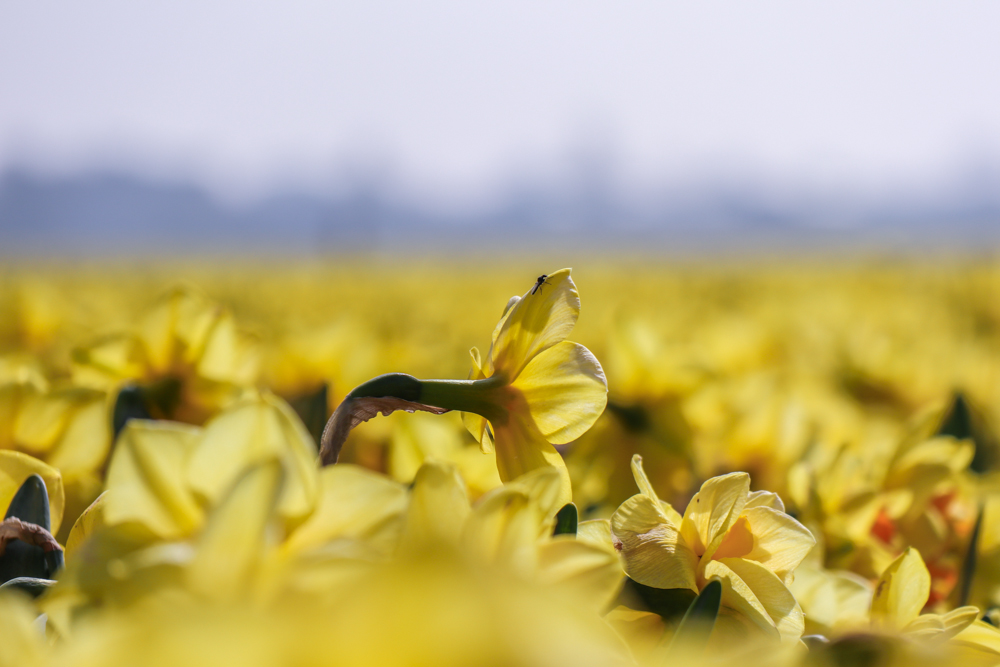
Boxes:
[0,257,1000,667]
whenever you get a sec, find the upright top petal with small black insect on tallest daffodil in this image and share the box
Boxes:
[490,269,580,381]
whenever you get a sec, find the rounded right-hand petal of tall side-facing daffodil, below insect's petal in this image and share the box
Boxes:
[514,341,608,445]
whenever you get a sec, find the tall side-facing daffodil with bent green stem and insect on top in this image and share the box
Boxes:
[321,269,608,502]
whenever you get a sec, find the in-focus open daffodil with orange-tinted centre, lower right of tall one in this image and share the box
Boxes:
[611,456,815,641]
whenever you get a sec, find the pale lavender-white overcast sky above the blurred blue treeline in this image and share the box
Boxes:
[0,0,1000,204]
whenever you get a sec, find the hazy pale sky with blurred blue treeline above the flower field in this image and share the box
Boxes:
[0,0,1000,259]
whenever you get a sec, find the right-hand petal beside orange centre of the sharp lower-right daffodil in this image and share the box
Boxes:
[743,506,816,583]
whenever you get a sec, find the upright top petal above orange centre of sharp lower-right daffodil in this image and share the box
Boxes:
[681,472,750,559]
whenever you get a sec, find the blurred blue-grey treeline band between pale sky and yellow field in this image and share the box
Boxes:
[0,170,1000,257]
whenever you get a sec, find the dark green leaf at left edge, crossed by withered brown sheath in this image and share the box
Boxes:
[0,475,64,582]
